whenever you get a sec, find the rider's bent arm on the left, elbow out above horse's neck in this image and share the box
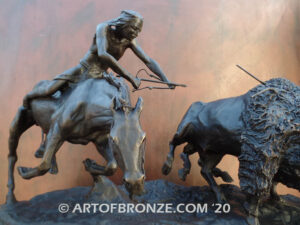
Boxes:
[96,23,139,88]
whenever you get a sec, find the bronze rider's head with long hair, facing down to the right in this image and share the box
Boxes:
[112,10,144,40]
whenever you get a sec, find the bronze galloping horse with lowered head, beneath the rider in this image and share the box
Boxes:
[6,75,146,204]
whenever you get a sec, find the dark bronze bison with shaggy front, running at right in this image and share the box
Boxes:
[162,78,300,224]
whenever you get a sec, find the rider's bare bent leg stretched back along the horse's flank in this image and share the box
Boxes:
[23,80,68,108]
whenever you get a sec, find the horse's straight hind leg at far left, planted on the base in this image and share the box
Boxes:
[6,107,34,204]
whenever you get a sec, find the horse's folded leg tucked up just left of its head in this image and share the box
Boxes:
[83,140,117,177]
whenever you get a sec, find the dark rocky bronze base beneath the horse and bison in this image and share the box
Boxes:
[0,177,300,225]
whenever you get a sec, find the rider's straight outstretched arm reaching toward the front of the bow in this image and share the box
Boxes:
[130,40,169,86]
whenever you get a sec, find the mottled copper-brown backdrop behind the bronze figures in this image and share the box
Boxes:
[0,0,300,204]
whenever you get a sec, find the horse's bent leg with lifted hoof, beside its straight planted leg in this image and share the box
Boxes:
[18,123,63,179]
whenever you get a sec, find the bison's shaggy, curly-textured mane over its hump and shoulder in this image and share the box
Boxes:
[239,78,300,196]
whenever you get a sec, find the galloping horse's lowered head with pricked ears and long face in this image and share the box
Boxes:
[109,97,146,196]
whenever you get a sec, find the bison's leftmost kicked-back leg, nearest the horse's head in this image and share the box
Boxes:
[162,123,194,175]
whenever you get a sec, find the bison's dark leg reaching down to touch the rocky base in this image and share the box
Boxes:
[198,152,225,203]
